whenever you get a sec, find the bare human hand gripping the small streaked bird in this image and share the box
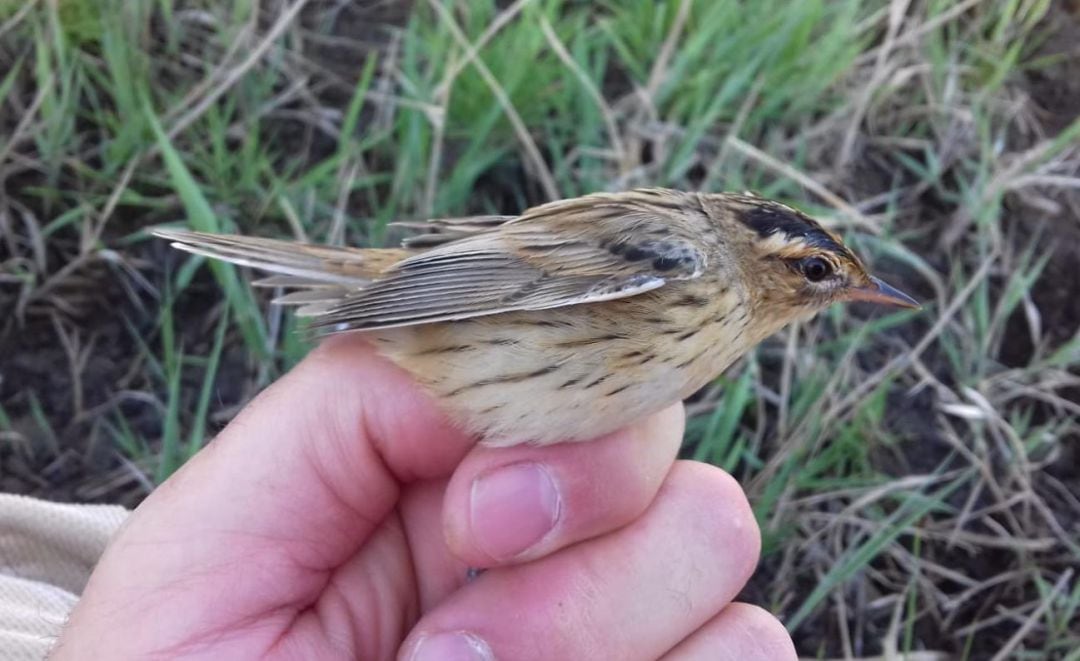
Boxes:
[53,337,795,661]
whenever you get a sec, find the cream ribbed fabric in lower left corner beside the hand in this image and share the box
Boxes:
[0,494,127,661]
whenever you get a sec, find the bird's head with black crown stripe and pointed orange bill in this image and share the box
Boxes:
[705,194,919,325]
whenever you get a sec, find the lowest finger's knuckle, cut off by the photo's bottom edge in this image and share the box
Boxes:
[662,604,798,661]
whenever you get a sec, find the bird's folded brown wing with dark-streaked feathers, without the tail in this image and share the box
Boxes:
[314,186,706,332]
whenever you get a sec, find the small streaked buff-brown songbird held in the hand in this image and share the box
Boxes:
[154,189,918,446]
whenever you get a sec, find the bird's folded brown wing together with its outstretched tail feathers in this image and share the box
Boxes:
[154,191,706,333]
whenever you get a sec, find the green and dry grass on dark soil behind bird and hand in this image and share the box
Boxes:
[0,0,1080,660]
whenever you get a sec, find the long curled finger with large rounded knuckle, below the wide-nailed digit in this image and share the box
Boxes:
[402,462,760,661]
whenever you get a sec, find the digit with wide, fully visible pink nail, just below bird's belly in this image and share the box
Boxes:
[443,405,684,567]
